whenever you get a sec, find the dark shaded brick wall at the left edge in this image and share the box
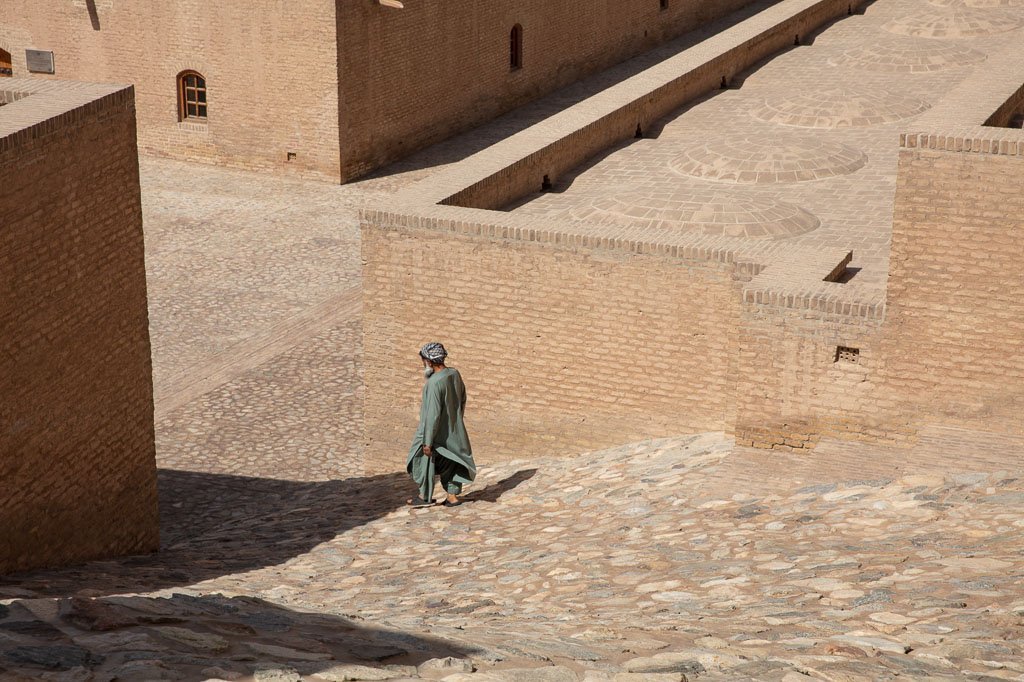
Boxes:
[0,81,158,572]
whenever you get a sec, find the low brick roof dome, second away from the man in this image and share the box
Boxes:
[669,136,867,184]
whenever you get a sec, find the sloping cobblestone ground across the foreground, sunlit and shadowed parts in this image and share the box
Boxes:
[0,434,1024,682]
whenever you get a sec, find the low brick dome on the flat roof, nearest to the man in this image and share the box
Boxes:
[566,189,821,240]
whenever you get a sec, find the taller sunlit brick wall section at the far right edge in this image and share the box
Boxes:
[884,147,1024,434]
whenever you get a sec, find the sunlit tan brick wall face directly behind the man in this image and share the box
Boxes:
[362,216,739,469]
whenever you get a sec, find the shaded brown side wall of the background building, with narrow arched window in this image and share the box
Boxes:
[338,0,752,178]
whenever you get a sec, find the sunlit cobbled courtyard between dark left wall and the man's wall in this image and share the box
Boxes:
[141,159,374,480]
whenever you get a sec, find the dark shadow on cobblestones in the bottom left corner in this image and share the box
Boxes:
[0,594,474,680]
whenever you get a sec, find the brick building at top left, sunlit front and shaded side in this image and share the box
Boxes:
[0,0,751,181]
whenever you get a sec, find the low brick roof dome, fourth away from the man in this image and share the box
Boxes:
[830,40,985,74]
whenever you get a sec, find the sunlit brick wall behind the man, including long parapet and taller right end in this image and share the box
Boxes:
[362,1,1024,466]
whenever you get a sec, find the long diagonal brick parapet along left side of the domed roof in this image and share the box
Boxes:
[401,0,862,209]
